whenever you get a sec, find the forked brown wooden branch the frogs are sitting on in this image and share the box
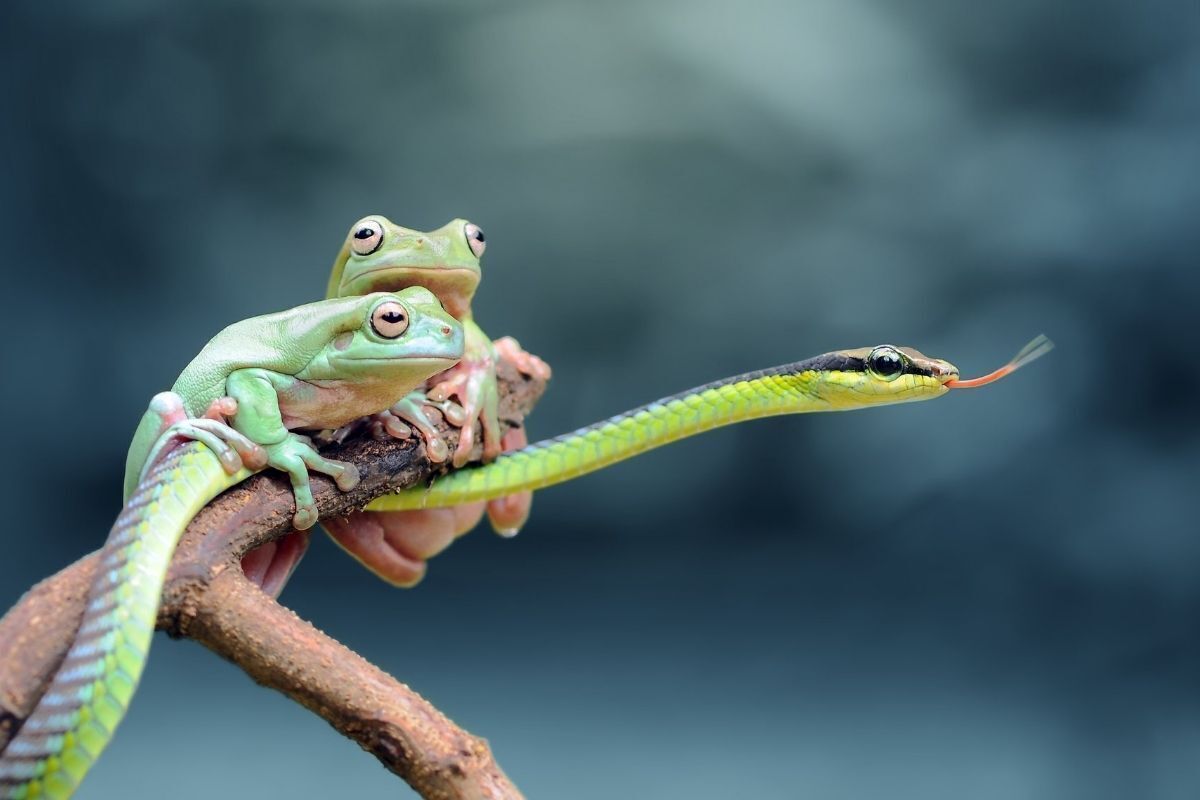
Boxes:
[0,361,545,800]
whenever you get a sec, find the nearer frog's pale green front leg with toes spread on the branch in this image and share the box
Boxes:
[226,368,359,530]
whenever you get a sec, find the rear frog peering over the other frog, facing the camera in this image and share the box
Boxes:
[326,215,550,587]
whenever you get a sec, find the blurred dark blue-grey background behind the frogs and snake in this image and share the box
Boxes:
[0,0,1200,800]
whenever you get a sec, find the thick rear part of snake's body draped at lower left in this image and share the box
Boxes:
[0,443,251,800]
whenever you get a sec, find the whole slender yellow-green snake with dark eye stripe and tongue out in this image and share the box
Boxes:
[0,337,1051,800]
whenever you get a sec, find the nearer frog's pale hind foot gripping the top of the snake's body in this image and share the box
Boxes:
[138,392,266,480]
